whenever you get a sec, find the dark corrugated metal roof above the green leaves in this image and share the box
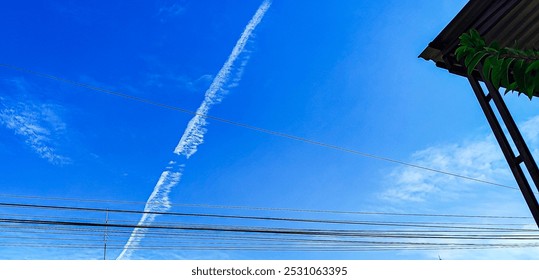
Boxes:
[419,0,539,80]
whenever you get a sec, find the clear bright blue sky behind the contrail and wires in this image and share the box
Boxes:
[0,0,539,259]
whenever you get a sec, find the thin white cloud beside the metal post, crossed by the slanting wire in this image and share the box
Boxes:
[380,116,539,203]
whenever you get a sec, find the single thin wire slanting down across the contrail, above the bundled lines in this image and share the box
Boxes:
[0,63,519,190]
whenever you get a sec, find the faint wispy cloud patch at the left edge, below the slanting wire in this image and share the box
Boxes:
[0,79,71,165]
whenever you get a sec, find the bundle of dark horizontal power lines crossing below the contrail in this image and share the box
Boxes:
[0,194,539,258]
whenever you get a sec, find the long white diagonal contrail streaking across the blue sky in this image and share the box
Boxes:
[117,0,271,260]
